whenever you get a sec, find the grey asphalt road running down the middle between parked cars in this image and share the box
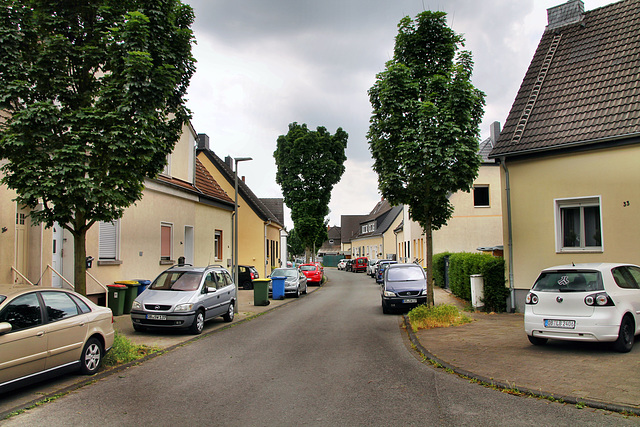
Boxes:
[0,270,640,426]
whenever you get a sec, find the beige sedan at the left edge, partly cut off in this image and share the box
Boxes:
[0,285,114,392]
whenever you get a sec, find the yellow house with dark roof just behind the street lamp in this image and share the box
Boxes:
[197,134,286,277]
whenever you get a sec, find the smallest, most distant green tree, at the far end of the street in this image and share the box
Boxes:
[273,122,349,260]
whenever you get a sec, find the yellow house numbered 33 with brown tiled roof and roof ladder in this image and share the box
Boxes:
[490,0,640,311]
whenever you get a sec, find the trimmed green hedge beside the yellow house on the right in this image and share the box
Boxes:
[433,252,509,312]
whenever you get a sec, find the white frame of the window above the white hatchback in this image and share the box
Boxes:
[553,196,604,253]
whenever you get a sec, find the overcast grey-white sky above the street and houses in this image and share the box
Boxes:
[183,0,612,229]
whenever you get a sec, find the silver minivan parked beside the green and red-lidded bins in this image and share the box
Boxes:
[131,265,237,335]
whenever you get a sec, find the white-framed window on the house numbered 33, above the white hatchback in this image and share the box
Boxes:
[555,197,602,252]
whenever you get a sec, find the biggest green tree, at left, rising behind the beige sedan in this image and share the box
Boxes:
[0,0,195,294]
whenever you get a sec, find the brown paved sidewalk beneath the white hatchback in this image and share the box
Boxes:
[409,288,640,415]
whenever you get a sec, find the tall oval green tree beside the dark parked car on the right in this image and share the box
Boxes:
[367,11,484,305]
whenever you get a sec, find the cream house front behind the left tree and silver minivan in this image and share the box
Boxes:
[0,125,233,302]
